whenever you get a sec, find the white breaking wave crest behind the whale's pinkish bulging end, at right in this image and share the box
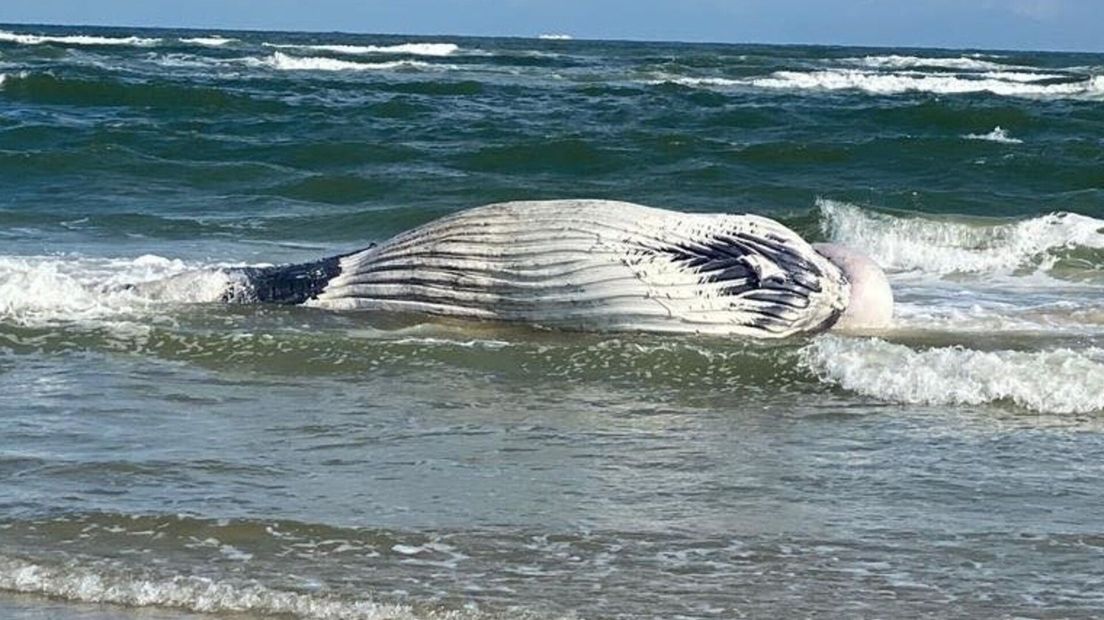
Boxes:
[817,199,1104,274]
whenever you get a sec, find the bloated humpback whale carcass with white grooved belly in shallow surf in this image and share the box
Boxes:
[208,200,893,338]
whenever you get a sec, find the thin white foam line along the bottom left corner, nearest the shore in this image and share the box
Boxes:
[0,556,478,620]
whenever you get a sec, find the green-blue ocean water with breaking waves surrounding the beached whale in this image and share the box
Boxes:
[0,21,1104,620]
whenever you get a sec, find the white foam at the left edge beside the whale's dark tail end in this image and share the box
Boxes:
[0,255,232,327]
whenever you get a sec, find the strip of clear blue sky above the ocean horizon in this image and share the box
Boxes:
[0,0,1104,52]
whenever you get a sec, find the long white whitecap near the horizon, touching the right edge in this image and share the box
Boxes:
[749,70,1104,99]
